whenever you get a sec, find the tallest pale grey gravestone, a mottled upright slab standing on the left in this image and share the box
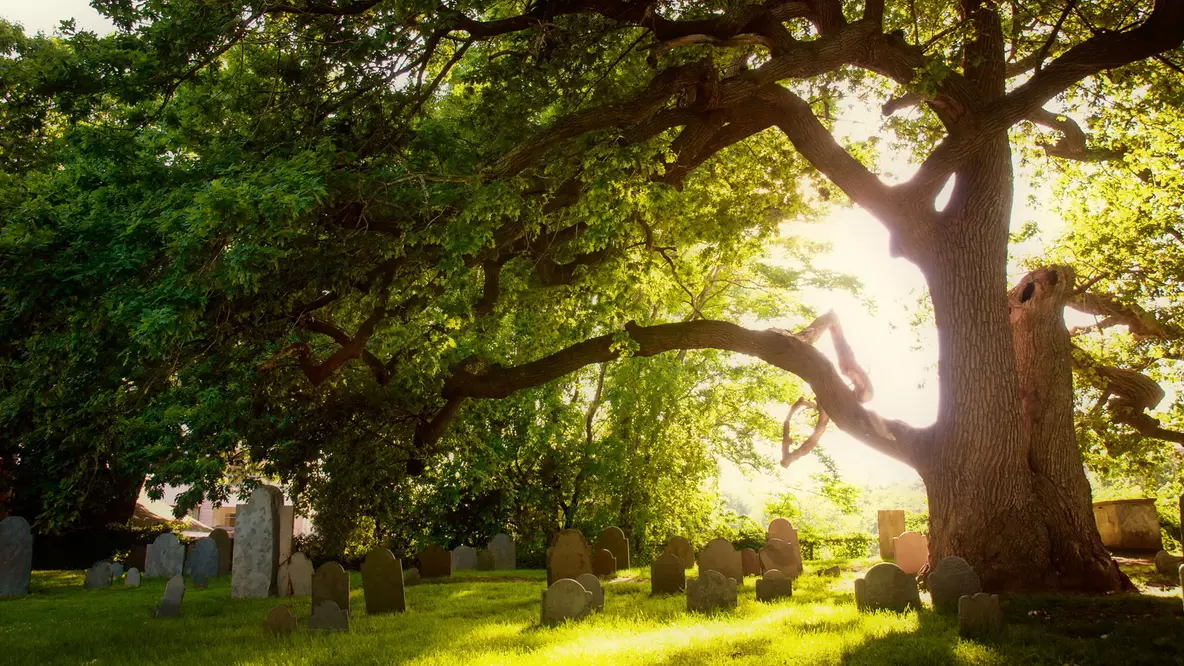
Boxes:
[230,486,283,598]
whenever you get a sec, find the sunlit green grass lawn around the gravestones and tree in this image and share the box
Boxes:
[0,554,1184,666]
